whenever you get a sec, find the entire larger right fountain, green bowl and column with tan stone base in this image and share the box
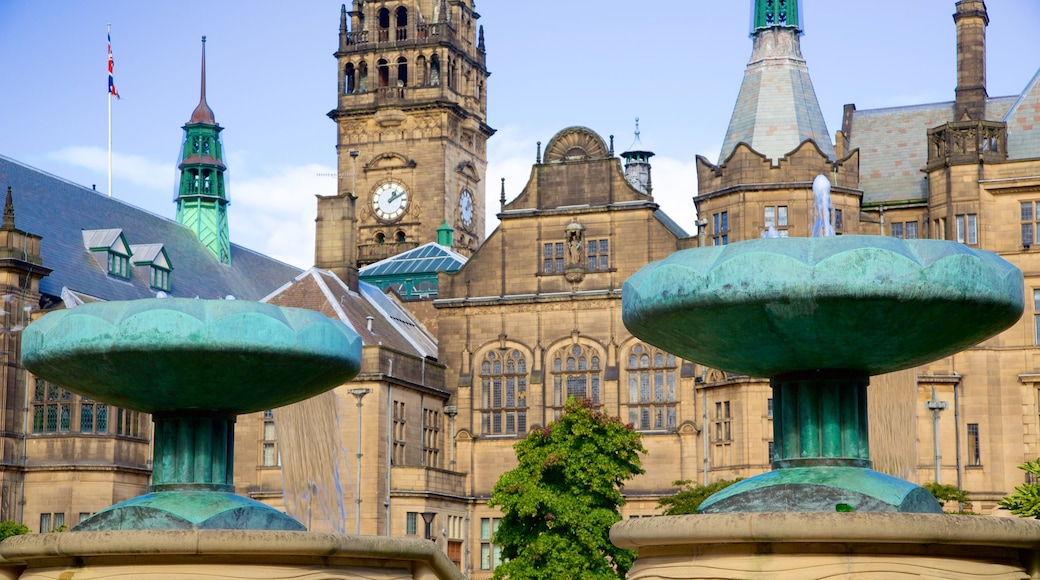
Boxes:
[610,236,1040,580]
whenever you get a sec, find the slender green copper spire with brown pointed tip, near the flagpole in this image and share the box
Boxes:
[176,36,231,264]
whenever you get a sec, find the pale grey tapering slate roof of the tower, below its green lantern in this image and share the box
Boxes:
[719,28,834,164]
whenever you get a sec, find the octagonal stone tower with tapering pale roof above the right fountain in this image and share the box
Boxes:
[694,0,862,245]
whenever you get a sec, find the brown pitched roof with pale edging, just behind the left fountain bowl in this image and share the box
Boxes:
[261,268,437,359]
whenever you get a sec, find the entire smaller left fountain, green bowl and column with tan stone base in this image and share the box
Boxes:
[8,298,463,580]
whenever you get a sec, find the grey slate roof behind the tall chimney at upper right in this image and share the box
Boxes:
[849,97,1019,208]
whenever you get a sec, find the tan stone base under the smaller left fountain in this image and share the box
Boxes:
[0,530,463,580]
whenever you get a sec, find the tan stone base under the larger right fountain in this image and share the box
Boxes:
[610,512,1040,580]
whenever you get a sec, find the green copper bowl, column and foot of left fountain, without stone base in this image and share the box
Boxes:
[22,298,361,532]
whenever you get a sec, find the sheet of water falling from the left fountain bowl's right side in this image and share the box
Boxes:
[275,390,349,533]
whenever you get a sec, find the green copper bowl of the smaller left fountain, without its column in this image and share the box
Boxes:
[22,298,361,414]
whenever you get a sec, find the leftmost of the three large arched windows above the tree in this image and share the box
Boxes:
[480,349,527,434]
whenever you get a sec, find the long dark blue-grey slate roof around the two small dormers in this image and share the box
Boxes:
[0,156,301,300]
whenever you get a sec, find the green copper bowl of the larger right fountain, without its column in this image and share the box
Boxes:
[622,236,1023,377]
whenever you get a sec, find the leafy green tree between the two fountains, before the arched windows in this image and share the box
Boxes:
[489,399,646,580]
